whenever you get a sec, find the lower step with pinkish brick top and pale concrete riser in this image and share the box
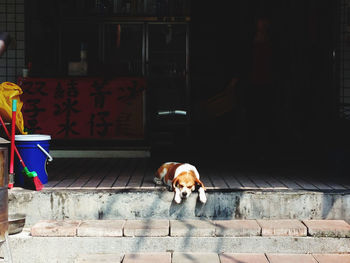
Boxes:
[4,219,350,263]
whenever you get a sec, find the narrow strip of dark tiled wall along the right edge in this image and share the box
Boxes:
[338,0,350,120]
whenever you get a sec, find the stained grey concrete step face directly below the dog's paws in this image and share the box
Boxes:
[8,190,350,227]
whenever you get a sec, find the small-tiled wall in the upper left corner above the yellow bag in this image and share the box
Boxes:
[0,0,25,83]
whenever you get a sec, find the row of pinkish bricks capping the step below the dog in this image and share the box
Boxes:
[31,219,350,238]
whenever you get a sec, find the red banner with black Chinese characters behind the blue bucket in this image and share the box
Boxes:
[18,78,145,139]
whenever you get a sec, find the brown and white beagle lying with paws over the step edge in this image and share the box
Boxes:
[154,162,207,204]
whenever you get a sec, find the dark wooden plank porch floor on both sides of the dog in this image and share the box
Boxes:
[44,158,350,192]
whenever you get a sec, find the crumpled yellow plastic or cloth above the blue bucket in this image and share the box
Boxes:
[0,82,27,134]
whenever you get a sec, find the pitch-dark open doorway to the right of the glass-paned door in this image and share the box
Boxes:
[191,0,336,163]
